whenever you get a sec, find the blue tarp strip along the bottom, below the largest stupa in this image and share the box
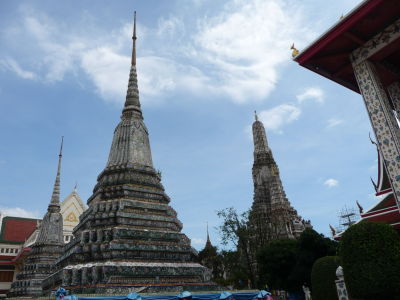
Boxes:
[64,293,257,300]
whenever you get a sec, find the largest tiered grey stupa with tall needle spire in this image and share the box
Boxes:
[44,14,214,293]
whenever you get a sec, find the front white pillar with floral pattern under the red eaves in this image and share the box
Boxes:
[353,60,400,205]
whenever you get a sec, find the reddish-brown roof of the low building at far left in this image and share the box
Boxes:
[0,217,38,244]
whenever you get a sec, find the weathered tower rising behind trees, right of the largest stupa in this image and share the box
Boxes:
[250,114,311,248]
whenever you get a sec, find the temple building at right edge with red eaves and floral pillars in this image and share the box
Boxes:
[294,0,400,218]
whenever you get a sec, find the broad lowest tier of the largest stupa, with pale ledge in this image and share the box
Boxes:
[43,261,217,293]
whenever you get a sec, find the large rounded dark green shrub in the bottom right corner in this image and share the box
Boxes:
[339,222,400,299]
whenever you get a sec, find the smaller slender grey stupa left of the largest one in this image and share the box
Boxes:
[9,141,64,297]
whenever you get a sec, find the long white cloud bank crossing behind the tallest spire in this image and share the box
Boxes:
[0,0,312,103]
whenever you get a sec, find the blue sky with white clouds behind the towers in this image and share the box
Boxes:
[0,0,377,249]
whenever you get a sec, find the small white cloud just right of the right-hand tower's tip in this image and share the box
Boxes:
[258,104,301,132]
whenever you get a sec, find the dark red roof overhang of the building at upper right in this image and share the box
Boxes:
[295,0,400,93]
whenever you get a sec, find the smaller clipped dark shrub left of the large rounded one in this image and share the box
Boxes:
[311,256,339,300]
